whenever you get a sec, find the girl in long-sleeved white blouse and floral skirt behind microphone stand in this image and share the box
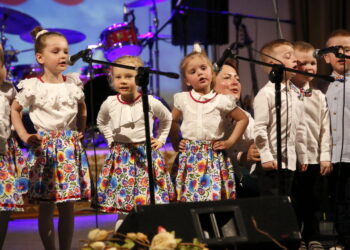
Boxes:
[97,56,174,216]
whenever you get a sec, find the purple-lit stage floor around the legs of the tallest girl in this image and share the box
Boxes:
[3,214,117,250]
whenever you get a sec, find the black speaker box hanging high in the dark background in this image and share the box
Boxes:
[172,0,229,45]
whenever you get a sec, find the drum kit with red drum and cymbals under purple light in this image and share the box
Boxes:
[0,0,170,95]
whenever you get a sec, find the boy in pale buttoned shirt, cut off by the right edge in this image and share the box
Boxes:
[324,30,350,249]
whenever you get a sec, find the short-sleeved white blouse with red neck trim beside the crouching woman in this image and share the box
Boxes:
[174,90,237,140]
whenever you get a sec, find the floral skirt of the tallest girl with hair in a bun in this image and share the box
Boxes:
[28,130,91,203]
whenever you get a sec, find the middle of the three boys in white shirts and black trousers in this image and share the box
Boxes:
[292,41,332,249]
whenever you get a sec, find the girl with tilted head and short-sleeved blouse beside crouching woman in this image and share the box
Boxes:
[170,45,248,202]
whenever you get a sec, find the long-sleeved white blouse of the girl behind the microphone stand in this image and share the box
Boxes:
[97,95,172,146]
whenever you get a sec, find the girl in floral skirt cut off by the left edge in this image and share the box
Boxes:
[0,45,28,249]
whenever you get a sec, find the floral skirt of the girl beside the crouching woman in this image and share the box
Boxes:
[172,140,236,202]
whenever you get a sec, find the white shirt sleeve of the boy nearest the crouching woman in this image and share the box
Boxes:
[254,89,274,163]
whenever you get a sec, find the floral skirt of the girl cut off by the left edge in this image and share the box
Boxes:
[0,137,28,211]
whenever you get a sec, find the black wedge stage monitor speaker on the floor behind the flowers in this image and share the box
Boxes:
[118,196,301,250]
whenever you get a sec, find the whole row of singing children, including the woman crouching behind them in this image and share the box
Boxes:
[0,24,350,249]
